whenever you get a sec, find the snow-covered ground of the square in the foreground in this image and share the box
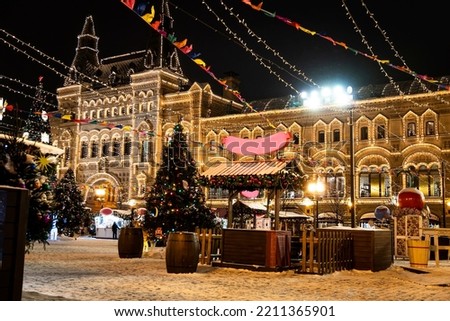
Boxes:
[22,232,450,301]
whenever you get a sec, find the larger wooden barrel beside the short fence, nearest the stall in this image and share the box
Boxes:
[166,232,200,273]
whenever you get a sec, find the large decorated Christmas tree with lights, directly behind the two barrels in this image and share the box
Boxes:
[144,123,216,234]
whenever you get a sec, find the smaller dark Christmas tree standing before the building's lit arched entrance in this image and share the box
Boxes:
[54,168,90,236]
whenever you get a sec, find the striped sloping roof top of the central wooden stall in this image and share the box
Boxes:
[201,160,289,177]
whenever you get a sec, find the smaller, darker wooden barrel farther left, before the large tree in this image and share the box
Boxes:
[118,227,144,258]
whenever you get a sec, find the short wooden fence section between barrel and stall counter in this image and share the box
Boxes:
[195,229,222,264]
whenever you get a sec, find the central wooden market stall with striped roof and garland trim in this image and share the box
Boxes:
[200,159,303,270]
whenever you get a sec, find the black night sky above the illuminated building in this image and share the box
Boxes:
[0,0,450,108]
